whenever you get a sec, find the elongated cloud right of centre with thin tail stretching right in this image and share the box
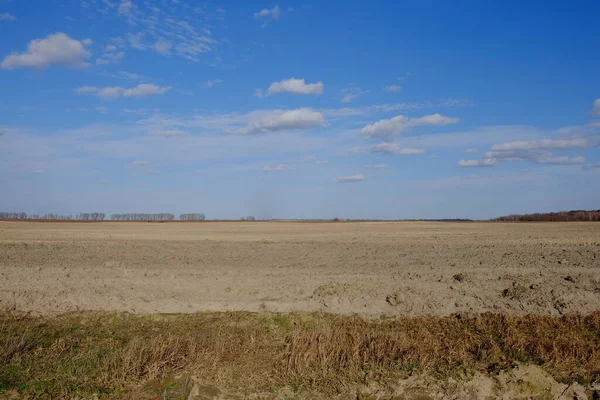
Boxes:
[362,114,460,141]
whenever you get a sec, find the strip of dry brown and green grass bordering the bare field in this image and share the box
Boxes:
[0,312,600,398]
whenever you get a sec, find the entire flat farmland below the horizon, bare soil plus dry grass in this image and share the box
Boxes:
[0,221,600,398]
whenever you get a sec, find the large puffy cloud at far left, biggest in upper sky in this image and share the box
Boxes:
[1,32,92,69]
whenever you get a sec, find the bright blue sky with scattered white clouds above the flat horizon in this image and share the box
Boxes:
[0,0,600,218]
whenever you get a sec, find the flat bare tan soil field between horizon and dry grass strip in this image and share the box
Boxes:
[0,221,600,317]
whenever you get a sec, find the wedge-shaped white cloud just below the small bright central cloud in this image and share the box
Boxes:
[234,108,325,135]
